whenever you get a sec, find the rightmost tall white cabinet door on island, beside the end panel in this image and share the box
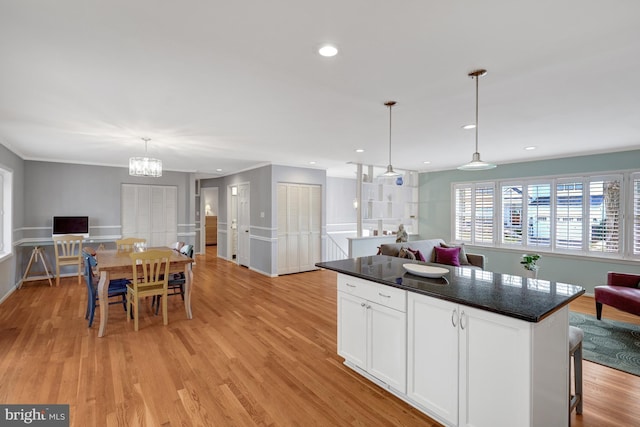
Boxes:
[459,306,528,427]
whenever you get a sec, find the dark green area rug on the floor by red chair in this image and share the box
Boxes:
[569,311,640,376]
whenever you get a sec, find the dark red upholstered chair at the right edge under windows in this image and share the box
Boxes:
[595,271,640,320]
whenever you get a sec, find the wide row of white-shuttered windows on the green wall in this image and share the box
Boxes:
[453,172,640,258]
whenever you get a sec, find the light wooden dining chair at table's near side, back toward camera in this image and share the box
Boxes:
[127,249,172,331]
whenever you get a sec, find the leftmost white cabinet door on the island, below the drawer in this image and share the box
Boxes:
[338,292,367,370]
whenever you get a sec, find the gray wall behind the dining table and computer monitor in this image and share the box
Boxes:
[0,152,195,298]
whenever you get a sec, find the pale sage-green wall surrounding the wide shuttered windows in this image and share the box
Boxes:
[419,150,640,293]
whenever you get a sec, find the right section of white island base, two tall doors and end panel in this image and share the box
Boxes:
[407,292,569,427]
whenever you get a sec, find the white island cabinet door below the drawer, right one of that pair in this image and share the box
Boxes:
[366,301,407,393]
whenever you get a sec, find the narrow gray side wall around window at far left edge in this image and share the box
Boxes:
[0,144,25,301]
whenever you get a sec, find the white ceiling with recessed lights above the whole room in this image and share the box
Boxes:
[0,0,640,176]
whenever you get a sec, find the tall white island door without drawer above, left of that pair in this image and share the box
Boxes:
[407,292,459,425]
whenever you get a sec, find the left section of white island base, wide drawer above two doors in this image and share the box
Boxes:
[338,274,407,393]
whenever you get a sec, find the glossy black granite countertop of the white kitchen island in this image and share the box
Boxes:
[316,255,584,322]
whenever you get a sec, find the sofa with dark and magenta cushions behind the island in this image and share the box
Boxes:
[378,239,485,270]
